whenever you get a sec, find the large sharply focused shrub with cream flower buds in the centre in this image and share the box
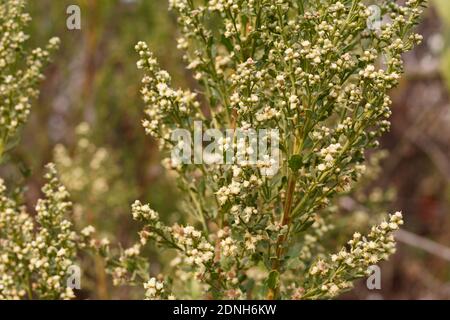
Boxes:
[125,0,425,299]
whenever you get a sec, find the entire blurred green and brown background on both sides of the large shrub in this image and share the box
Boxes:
[2,0,450,299]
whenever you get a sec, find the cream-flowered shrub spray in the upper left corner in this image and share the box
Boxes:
[0,0,59,157]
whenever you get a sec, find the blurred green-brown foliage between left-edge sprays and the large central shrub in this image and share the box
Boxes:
[16,0,186,218]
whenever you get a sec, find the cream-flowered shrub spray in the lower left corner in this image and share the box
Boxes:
[0,165,80,299]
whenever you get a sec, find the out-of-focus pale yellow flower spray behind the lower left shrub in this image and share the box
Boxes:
[53,122,133,233]
